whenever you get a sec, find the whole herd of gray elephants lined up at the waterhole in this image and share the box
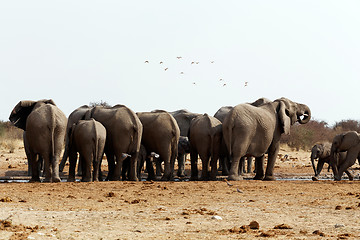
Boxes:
[9,98,360,182]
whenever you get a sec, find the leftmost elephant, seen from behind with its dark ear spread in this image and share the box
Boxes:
[9,99,67,182]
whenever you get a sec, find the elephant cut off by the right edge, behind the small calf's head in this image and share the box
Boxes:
[330,131,360,181]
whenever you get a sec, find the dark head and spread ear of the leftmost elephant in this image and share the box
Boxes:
[9,99,56,131]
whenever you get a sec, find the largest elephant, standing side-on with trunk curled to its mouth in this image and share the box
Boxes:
[223,98,311,180]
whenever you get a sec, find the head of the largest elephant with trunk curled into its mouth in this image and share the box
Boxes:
[274,98,311,134]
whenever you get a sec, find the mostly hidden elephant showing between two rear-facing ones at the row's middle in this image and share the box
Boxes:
[169,109,201,177]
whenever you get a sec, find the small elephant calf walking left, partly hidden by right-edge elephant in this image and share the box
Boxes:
[310,142,354,180]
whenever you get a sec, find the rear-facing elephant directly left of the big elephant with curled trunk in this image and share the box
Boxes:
[189,113,222,180]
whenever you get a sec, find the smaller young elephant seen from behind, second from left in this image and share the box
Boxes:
[68,119,106,182]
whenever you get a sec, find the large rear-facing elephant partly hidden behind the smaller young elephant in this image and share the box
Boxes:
[85,105,143,181]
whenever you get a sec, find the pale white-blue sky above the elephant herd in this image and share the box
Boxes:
[0,0,360,124]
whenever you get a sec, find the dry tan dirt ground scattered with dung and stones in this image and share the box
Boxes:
[0,142,360,239]
